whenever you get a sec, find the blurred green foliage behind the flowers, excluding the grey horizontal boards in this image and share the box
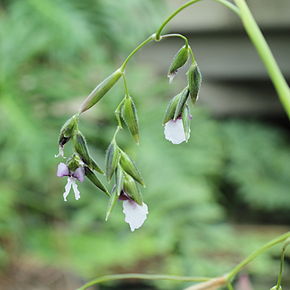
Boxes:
[0,0,290,289]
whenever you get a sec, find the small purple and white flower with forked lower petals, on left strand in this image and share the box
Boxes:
[56,162,85,201]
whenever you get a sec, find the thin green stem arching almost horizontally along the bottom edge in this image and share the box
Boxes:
[77,273,211,290]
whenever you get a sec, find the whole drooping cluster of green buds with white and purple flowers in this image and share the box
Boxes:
[56,37,201,231]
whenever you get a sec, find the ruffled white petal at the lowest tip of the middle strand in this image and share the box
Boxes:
[123,200,148,232]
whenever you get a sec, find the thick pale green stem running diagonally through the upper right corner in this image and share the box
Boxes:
[234,0,290,118]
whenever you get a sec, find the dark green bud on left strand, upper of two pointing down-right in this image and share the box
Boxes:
[73,131,104,174]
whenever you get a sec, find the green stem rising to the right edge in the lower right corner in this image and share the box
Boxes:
[226,232,290,281]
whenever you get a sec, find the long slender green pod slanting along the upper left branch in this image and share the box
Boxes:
[80,69,123,113]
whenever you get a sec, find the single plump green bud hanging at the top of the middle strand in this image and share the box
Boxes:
[122,96,139,144]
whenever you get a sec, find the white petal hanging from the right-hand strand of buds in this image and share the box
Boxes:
[164,118,186,144]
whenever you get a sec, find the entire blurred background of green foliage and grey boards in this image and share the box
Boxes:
[0,0,290,290]
